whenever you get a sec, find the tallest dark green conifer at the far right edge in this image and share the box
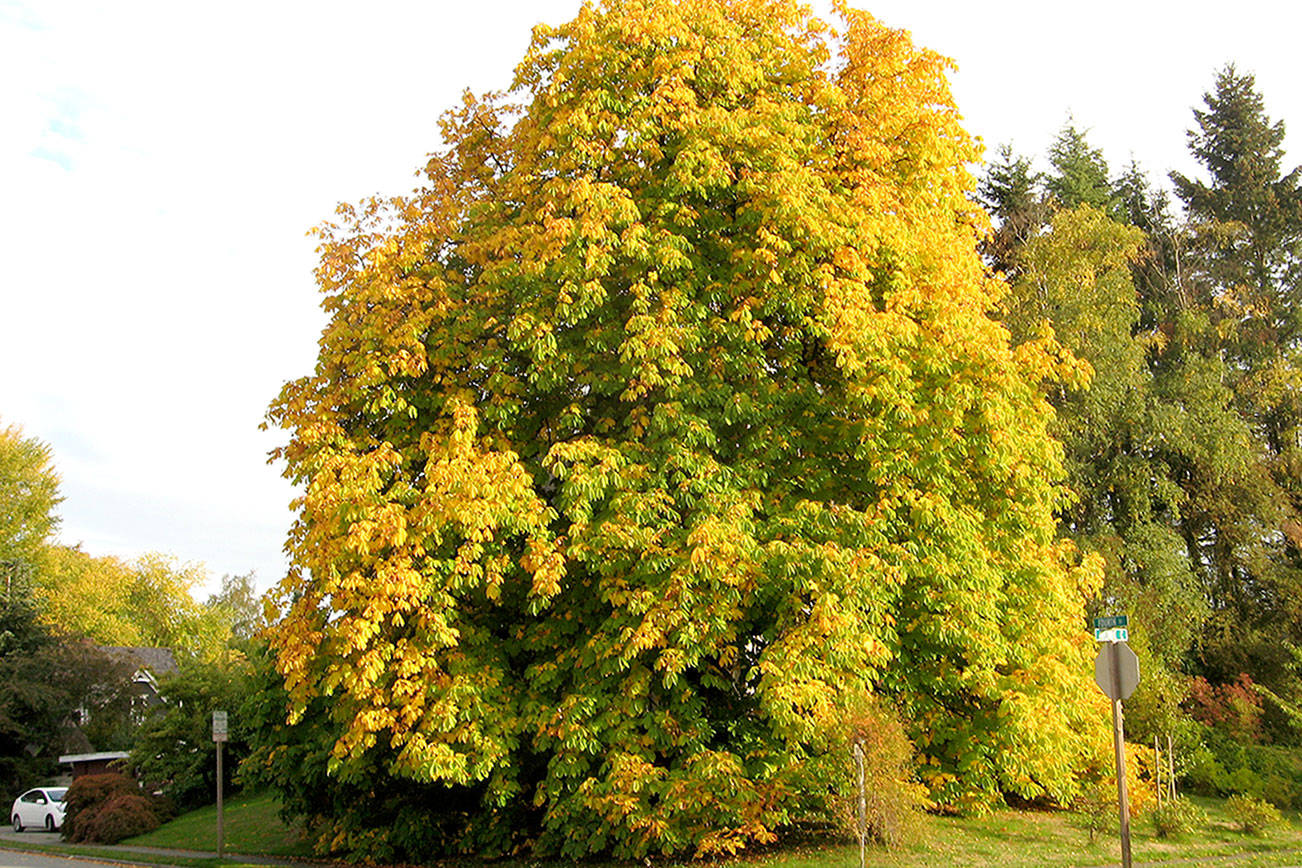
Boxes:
[1170,66,1302,718]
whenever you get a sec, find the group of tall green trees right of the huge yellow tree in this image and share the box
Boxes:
[979,66,1302,804]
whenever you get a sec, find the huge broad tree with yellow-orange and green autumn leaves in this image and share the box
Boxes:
[271,0,1103,856]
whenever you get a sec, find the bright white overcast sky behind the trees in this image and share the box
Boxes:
[0,0,1302,598]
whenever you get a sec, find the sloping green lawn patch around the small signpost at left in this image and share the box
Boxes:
[122,793,312,859]
